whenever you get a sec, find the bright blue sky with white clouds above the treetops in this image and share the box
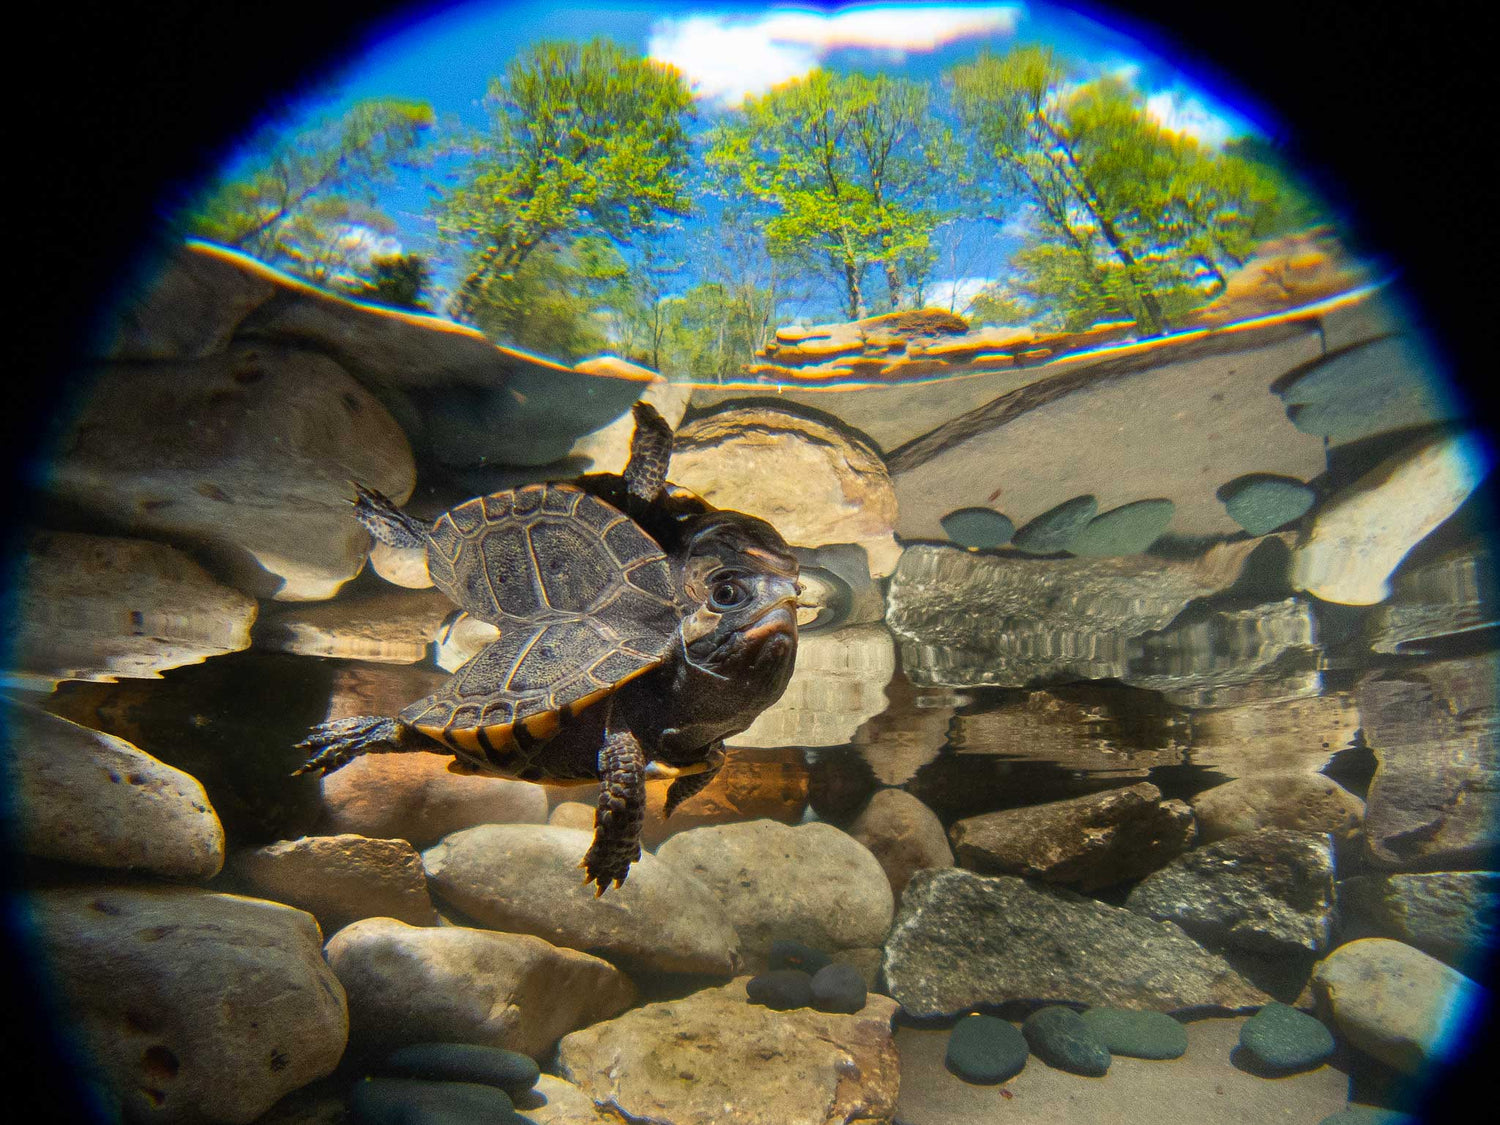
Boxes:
[237,0,1269,313]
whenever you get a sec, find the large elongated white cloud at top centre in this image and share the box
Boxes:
[648,5,1022,105]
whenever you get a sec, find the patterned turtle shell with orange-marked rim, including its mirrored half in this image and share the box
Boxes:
[399,485,681,776]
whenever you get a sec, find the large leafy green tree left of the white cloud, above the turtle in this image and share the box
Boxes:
[438,39,692,317]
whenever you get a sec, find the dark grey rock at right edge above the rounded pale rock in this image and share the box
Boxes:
[1338,872,1500,971]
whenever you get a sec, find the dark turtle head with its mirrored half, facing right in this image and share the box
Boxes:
[678,512,801,687]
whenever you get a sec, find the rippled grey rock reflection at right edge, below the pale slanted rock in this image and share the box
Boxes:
[1367,543,1500,654]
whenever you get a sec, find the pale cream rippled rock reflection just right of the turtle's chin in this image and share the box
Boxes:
[726,626,896,747]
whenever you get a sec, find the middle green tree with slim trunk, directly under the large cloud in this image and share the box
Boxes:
[707,71,953,318]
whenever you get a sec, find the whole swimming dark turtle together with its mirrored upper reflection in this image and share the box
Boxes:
[299,404,798,894]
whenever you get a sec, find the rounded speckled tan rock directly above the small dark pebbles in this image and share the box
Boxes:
[654,821,896,969]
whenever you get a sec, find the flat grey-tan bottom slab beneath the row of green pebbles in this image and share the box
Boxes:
[896,1017,1349,1125]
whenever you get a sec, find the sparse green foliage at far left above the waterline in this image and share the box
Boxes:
[180,99,434,284]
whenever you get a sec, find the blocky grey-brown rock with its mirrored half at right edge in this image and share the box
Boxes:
[1356,653,1500,872]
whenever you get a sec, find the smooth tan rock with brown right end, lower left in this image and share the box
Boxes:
[327,918,636,1059]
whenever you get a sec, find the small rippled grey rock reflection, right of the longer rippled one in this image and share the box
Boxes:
[1121,599,1323,707]
